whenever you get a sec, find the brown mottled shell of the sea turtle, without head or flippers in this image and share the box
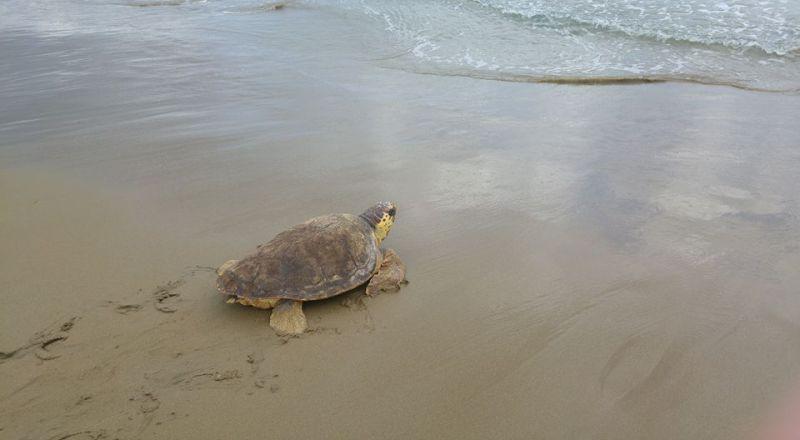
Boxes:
[217,214,380,301]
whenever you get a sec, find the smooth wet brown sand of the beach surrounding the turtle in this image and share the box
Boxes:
[0,3,800,439]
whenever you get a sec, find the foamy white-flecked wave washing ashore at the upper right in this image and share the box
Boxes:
[324,0,800,92]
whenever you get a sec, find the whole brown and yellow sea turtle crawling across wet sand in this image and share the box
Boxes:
[217,202,405,334]
